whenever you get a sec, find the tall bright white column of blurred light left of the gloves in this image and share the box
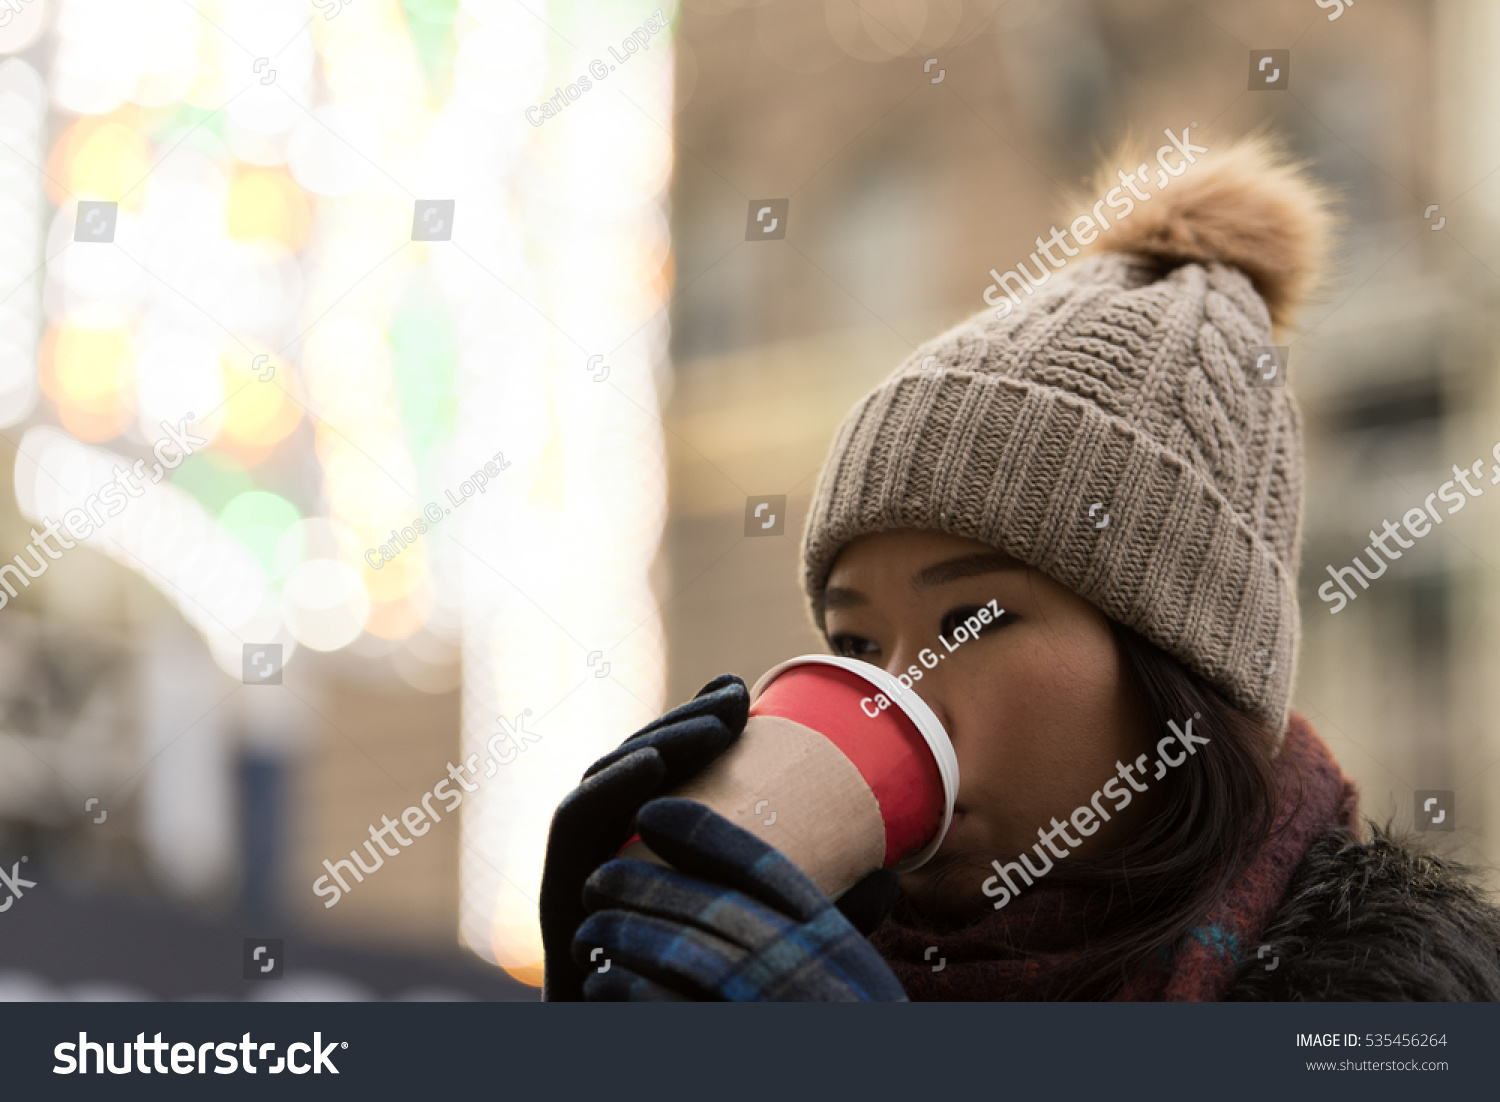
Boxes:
[444,6,672,984]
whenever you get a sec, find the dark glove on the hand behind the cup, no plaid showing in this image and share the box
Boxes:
[540,673,750,1002]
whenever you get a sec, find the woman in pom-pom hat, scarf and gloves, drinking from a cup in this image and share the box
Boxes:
[542,141,1500,1000]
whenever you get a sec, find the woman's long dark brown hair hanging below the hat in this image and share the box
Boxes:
[1050,621,1278,999]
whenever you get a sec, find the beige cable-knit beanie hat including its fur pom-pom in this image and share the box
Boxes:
[803,132,1331,735]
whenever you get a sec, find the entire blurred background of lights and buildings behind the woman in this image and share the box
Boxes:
[0,0,1500,999]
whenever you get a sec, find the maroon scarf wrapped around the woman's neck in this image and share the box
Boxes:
[870,712,1359,1002]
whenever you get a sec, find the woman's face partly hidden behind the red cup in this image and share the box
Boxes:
[824,531,1154,919]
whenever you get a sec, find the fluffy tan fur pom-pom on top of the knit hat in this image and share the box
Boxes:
[1094,135,1334,330]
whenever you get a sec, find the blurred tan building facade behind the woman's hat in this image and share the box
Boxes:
[666,0,1500,888]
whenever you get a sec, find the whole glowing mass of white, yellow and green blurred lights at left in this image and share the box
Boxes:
[10,0,675,984]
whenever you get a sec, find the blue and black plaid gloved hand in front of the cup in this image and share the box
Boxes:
[573,799,906,1002]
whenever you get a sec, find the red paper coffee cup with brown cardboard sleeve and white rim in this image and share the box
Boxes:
[621,655,959,898]
